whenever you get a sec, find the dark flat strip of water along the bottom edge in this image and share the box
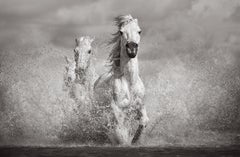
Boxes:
[0,146,240,157]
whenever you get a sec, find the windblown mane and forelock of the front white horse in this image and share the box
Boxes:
[108,15,133,72]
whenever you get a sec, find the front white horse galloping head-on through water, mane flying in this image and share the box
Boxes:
[94,15,149,144]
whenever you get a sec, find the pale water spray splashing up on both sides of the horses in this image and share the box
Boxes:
[0,32,240,146]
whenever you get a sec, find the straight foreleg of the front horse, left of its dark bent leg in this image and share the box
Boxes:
[112,103,129,145]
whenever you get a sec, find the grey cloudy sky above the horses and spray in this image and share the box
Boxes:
[0,0,240,48]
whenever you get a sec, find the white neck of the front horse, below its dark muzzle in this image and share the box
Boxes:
[120,48,139,83]
